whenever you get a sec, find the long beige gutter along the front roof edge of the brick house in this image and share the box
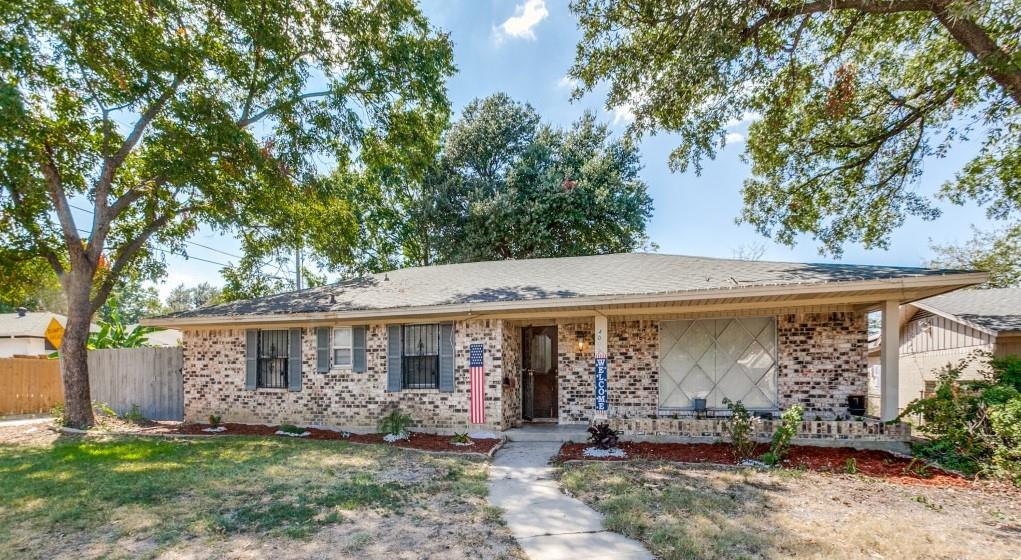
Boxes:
[139,272,988,328]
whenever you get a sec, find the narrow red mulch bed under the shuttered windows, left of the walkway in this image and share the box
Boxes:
[144,423,500,454]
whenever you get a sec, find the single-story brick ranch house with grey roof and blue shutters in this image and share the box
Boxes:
[146,253,985,439]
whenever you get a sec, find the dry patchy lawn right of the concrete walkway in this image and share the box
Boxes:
[562,462,1021,560]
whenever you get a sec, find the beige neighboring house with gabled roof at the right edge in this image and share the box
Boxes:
[870,288,1021,410]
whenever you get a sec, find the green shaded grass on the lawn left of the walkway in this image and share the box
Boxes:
[0,437,414,543]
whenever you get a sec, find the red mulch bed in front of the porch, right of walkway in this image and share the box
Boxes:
[558,441,970,486]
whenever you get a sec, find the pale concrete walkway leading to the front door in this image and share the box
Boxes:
[489,441,652,560]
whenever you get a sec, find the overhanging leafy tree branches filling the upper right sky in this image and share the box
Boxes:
[571,0,1021,254]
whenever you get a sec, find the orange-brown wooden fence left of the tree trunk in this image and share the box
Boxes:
[0,358,63,416]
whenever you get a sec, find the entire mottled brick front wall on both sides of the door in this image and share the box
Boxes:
[184,311,868,429]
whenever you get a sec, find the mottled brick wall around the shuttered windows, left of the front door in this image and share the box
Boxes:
[184,321,510,429]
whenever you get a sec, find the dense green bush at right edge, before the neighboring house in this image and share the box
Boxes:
[901,356,1021,484]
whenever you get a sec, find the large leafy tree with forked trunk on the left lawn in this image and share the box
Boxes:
[0,0,452,425]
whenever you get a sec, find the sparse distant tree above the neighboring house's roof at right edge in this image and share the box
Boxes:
[929,224,1021,288]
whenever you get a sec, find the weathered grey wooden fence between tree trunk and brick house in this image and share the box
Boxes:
[83,346,185,420]
